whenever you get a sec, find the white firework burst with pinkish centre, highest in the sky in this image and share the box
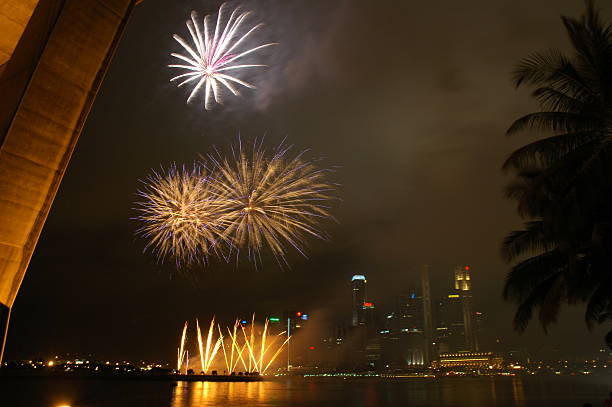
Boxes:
[168,4,276,110]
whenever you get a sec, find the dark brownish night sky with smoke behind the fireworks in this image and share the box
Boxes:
[7,0,612,361]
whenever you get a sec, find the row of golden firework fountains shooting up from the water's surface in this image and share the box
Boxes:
[176,314,290,375]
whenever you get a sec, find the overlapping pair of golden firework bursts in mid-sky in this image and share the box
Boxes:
[136,142,335,267]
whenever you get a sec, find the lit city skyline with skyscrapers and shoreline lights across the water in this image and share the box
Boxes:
[9,265,606,373]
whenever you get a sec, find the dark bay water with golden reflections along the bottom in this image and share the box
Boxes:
[0,376,612,407]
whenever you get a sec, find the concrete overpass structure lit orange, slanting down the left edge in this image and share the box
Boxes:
[0,0,142,361]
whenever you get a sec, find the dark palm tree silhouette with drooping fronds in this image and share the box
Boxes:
[502,0,612,348]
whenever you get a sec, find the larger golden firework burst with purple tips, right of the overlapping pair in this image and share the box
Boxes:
[208,142,335,264]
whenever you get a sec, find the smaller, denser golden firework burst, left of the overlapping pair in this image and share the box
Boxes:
[136,165,224,266]
